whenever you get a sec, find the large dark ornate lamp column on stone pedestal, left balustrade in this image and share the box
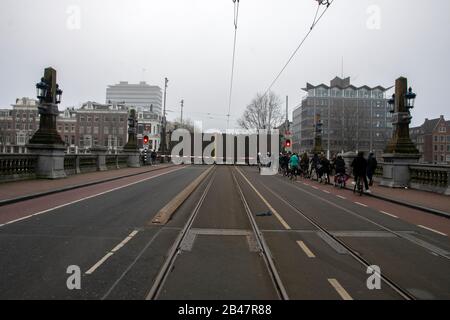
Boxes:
[27,68,66,179]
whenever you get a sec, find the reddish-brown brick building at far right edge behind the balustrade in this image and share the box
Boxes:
[410,115,450,164]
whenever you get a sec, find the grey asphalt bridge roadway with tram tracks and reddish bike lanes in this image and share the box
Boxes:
[0,166,450,300]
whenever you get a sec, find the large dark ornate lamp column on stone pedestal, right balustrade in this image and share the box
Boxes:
[380,77,420,187]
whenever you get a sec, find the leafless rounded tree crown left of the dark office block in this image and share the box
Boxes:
[238,92,283,130]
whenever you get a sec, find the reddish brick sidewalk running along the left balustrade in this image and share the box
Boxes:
[0,164,172,202]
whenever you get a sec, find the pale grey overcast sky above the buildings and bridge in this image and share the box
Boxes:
[0,0,450,128]
